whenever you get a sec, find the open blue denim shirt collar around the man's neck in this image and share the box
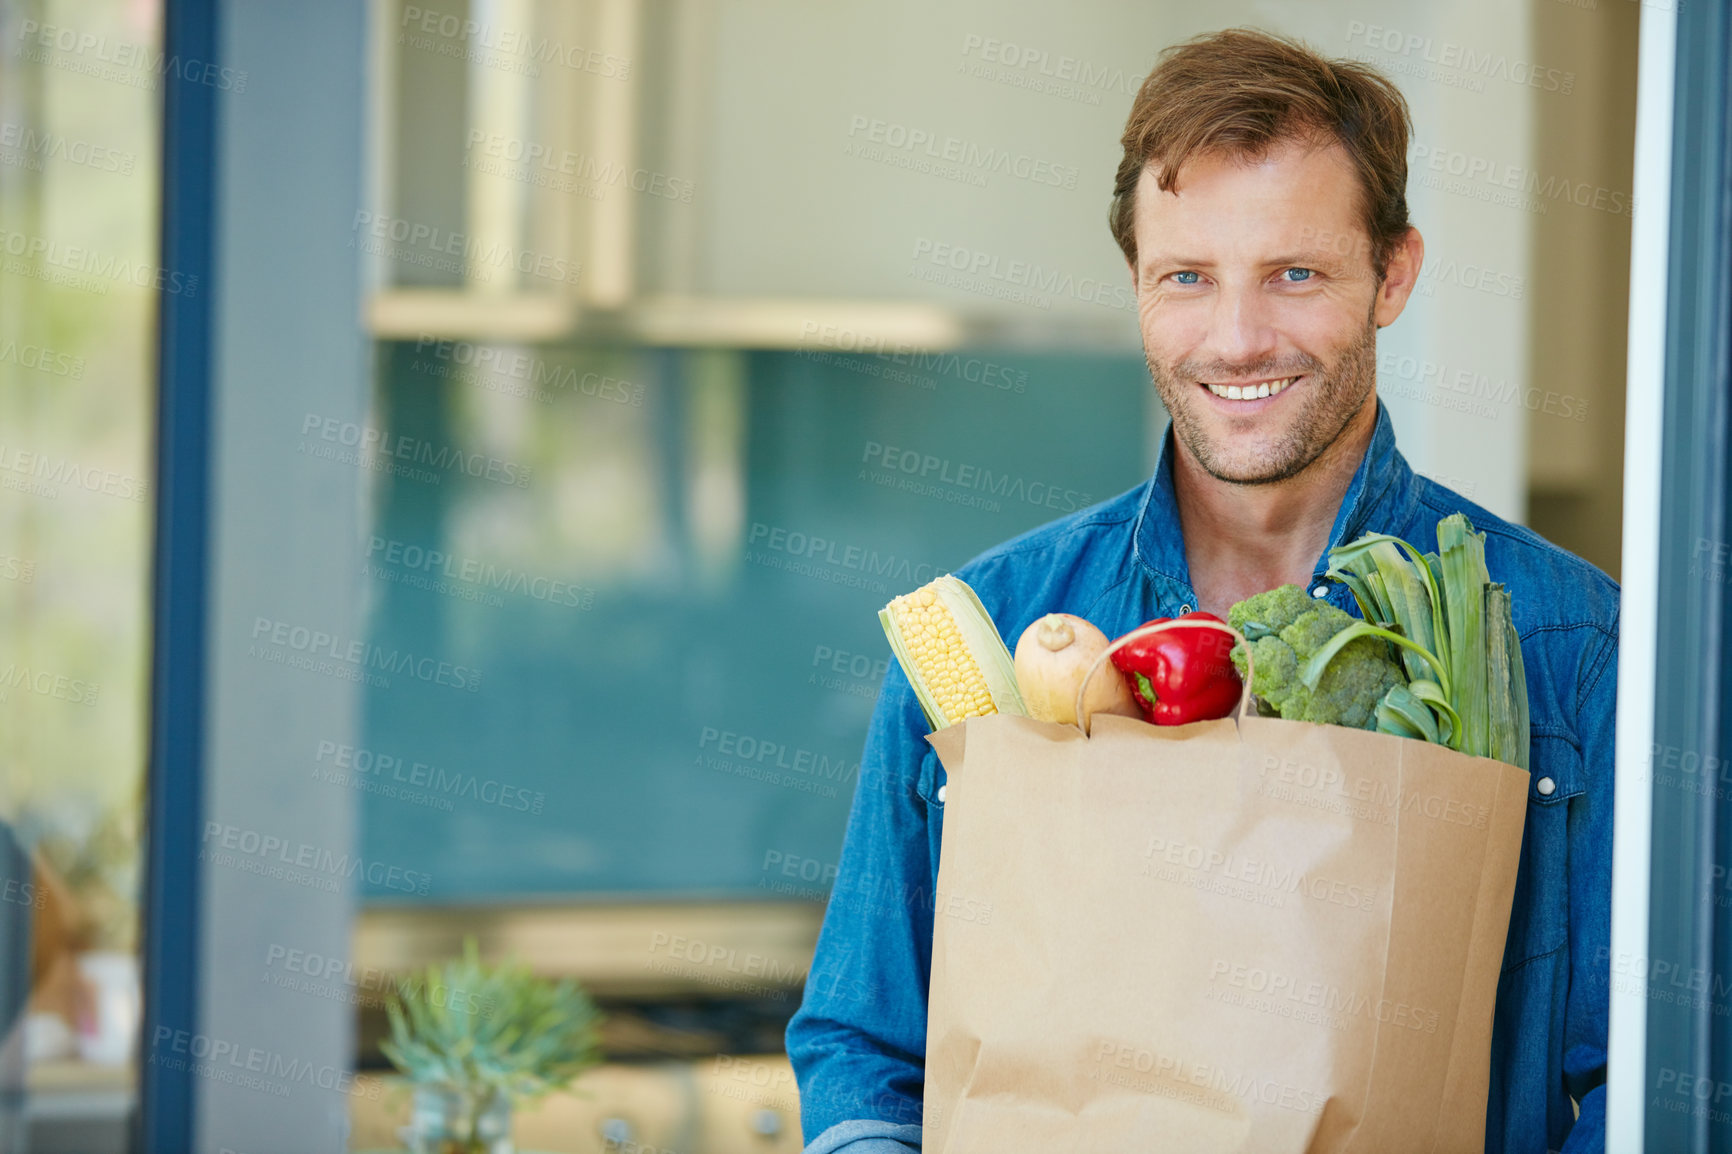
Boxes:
[1131,400,1419,589]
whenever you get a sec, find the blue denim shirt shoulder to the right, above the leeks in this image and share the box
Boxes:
[1413,475,1618,639]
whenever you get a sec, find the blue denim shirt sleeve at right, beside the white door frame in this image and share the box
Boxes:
[1564,619,1618,1154]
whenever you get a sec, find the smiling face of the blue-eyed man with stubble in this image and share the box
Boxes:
[1134,142,1417,485]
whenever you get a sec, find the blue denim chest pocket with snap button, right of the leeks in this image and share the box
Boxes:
[1503,733,1587,974]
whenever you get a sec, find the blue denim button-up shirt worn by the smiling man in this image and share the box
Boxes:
[786,402,1618,1154]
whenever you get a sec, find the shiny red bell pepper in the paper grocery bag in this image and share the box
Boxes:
[1112,612,1244,726]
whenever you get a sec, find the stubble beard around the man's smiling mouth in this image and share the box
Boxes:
[1143,308,1377,485]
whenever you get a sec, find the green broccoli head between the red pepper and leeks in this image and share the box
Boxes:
[1228,586,1406,729]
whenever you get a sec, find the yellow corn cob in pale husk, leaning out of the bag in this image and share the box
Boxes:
[878,574,1027,729]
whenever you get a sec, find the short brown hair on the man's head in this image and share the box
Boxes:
[1107,28,1413,279]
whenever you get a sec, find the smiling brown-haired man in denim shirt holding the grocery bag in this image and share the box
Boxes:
[788,31,1618,1154]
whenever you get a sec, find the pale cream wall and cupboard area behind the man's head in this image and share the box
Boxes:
[691,2,1544,518]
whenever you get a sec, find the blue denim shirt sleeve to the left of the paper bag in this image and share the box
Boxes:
[786,662,937,1154]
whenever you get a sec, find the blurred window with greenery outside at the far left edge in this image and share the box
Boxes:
[0,0,162,1136]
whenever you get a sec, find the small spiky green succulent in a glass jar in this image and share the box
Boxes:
[379,937,601,1154]
